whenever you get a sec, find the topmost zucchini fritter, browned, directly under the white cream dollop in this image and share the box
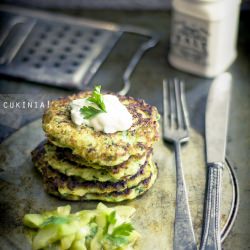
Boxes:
[43,92,159,166]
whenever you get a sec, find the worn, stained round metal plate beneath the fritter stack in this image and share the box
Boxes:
[0,120,238,250]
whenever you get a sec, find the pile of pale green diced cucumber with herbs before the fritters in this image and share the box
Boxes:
[23,203,139,250]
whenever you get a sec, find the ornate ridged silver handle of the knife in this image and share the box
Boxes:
[200,163,223,250]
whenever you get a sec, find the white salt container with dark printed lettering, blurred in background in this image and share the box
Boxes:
[169,0,240,77]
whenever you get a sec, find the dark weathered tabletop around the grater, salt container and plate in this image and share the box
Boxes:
[0,6,250,250]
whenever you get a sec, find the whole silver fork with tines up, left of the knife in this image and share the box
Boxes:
[163,78,197,250]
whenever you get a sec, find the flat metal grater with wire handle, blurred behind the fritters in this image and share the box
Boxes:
[0,6,158,94]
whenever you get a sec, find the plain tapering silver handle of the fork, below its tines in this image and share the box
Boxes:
[174,142,197,250]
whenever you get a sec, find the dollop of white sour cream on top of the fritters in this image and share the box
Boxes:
[70,95,133,133]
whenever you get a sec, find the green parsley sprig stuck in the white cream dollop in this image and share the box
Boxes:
[80,86,107,119]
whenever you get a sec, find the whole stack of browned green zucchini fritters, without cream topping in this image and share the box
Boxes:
[32,92,159,202]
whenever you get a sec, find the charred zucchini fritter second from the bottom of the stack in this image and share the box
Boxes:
[32,142,154,200]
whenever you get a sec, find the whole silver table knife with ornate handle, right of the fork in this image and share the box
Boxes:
[200,73,232,250]
